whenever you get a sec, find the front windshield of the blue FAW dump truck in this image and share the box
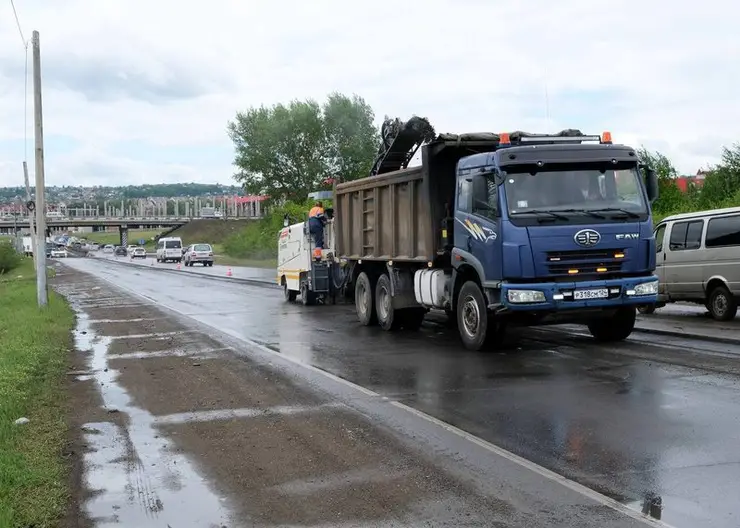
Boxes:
[504,168,647,216]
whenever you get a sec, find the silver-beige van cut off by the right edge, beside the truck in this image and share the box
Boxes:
[640,207,740,321]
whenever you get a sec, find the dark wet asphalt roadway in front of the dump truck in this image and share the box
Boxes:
[60,259,740,528]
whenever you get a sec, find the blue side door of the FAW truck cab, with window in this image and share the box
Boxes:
[455,174,501,281]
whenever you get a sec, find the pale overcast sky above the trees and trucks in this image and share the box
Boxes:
[0,0,740,186]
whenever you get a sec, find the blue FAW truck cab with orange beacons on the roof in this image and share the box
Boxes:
[451,133,658,346]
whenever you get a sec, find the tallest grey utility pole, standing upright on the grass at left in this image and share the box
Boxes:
[32,31,49,306]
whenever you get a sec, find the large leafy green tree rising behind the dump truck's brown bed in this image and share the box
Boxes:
[227,93,378,201]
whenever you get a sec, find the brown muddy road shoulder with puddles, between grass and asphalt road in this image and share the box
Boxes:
[53,268,518,528]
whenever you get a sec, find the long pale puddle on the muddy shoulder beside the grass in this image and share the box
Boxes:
[75,312,233,528]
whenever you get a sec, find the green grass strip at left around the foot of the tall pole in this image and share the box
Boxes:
[0,259,75,528]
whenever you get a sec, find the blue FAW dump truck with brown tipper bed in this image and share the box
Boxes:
[278,117,658,350]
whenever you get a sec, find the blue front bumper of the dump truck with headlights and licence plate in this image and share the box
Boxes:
[498,275,658,312]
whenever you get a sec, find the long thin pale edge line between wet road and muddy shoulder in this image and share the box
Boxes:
[76,268,675,528]
